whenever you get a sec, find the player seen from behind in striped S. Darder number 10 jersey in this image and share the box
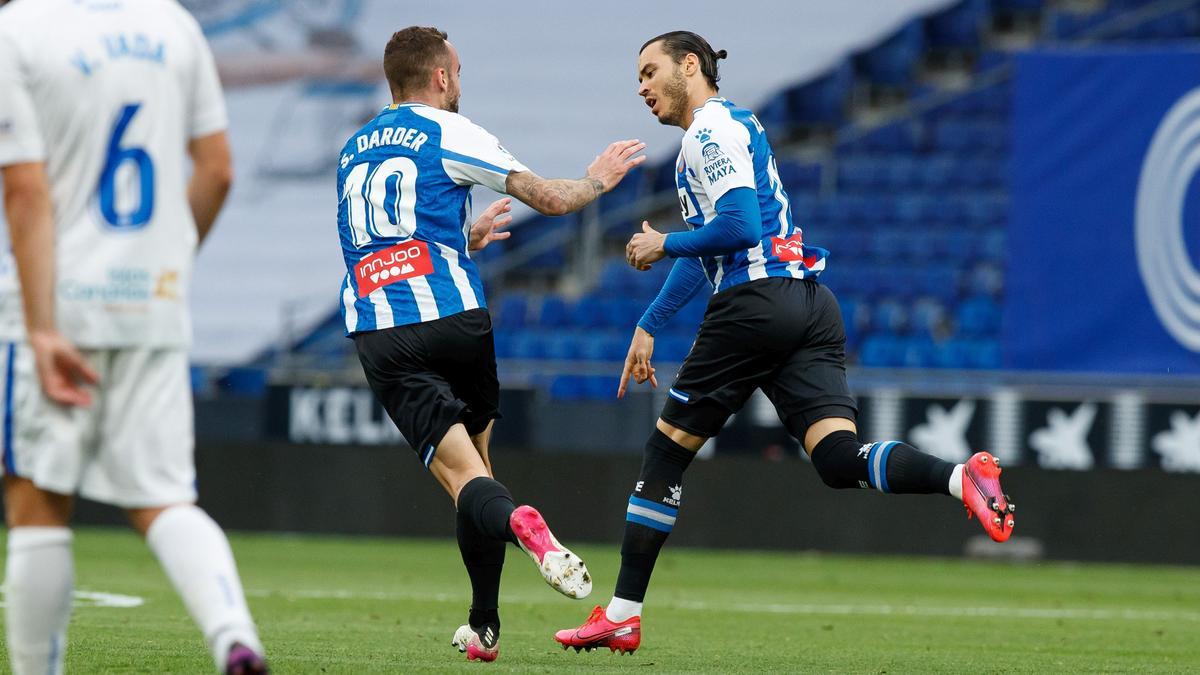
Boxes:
[337,26,644,661]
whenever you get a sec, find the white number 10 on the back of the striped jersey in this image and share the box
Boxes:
[342,157,416,249]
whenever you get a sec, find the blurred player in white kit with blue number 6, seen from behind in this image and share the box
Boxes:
[0,0,266,675]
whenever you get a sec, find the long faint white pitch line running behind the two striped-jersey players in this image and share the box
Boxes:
[246,589,1200,622]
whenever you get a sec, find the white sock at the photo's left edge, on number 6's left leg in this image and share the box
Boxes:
[5,527,74,675]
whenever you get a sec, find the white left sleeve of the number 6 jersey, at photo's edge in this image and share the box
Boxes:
[0,31,46,166]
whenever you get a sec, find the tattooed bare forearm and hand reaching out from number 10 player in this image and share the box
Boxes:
[504,139,646,216]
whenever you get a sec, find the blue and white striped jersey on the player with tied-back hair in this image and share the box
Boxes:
[676,96,828,292]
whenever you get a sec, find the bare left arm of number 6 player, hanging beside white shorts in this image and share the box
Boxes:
[0,162,98,406]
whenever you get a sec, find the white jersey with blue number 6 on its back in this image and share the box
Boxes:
[0,0,227,347]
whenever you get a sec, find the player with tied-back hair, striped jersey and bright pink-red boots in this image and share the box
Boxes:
[554,31,1013,652]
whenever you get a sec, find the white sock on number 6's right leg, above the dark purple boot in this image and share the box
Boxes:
[146,504,265,670]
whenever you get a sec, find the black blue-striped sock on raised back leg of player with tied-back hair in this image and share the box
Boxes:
[812,431,954,495]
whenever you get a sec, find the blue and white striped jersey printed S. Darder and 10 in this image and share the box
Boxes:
[337,103,528,335]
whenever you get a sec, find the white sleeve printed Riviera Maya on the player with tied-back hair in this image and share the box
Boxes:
[683,115,755,204]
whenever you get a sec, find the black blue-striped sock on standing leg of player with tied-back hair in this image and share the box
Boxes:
[613,429,696,602]
